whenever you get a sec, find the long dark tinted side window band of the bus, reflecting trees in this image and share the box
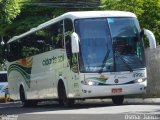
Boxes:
[7,21,64,61]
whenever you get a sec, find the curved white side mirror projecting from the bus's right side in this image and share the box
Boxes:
[144,29,156,49]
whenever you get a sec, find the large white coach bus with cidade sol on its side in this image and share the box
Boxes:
[7,11,155,107]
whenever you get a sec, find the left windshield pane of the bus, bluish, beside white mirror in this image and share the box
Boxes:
[75,18,113,72]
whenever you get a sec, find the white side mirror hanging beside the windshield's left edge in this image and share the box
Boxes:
[71,32,79,53]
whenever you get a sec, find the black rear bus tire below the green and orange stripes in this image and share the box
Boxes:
[20,87,37,107]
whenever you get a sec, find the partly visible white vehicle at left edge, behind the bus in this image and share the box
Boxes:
[0,71,8,101]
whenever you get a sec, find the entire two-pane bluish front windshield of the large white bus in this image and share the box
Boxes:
[75,17,145,73]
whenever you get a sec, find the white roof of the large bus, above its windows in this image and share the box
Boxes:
[7,11,136,43]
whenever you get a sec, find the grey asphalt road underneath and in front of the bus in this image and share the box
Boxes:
[0,101,160,120]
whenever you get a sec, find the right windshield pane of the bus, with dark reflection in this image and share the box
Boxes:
[108,18,145,71]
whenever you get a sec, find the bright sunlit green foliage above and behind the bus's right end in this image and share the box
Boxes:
[100,0,160,43]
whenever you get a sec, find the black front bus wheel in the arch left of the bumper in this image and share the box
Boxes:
[58,84,75,107]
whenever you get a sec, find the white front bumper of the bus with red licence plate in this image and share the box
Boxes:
[81,82,147,98]
